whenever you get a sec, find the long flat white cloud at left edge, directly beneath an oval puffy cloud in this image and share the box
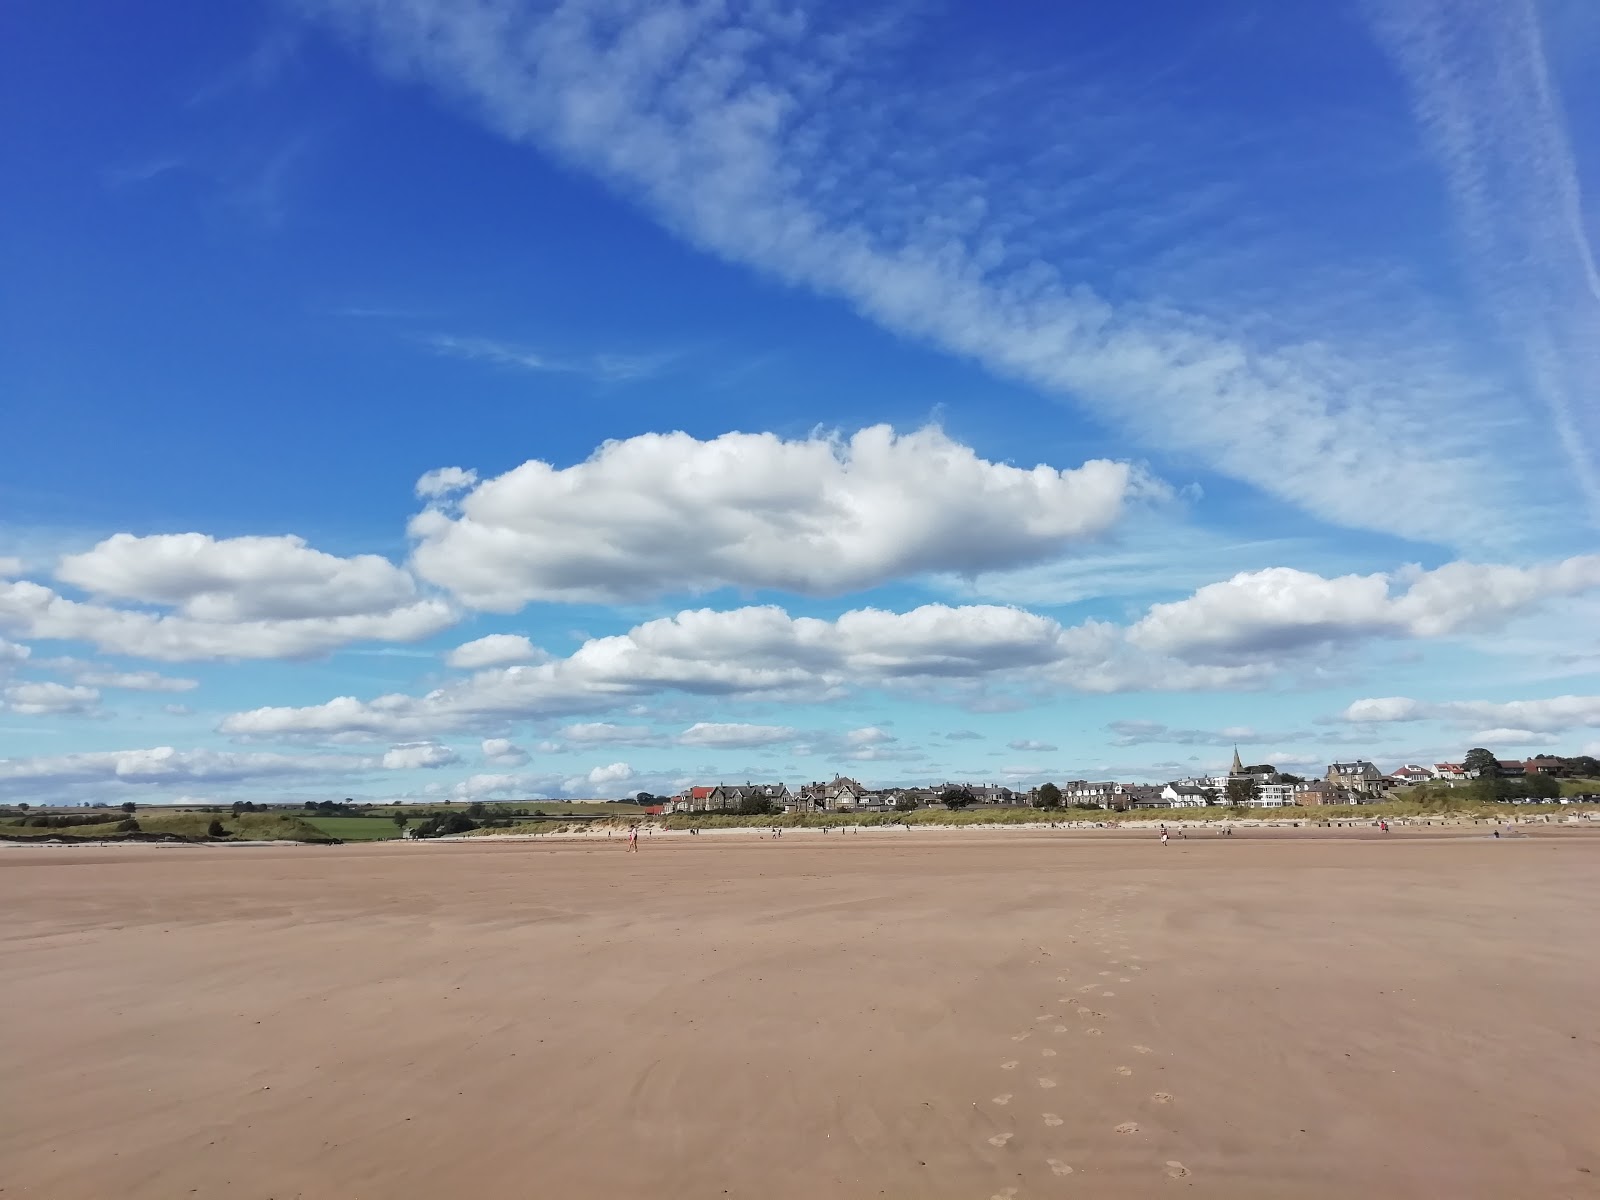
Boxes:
[0,579,456,662]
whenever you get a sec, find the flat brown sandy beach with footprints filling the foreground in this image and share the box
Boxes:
[0,827,1600,1200]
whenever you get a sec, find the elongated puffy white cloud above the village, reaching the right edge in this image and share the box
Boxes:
[1128,555,1600,661]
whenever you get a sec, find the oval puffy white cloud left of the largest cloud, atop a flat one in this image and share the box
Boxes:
[56,533,416,622]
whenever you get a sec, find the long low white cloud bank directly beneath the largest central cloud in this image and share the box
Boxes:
[221,605,1264,739]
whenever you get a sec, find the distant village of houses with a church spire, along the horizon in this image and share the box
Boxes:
[652,747,1600,814]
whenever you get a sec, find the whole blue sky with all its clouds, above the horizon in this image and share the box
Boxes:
[0,0,1600,803]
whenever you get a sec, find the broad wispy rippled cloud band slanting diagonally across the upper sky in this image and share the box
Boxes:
[305,0,1542,544]
